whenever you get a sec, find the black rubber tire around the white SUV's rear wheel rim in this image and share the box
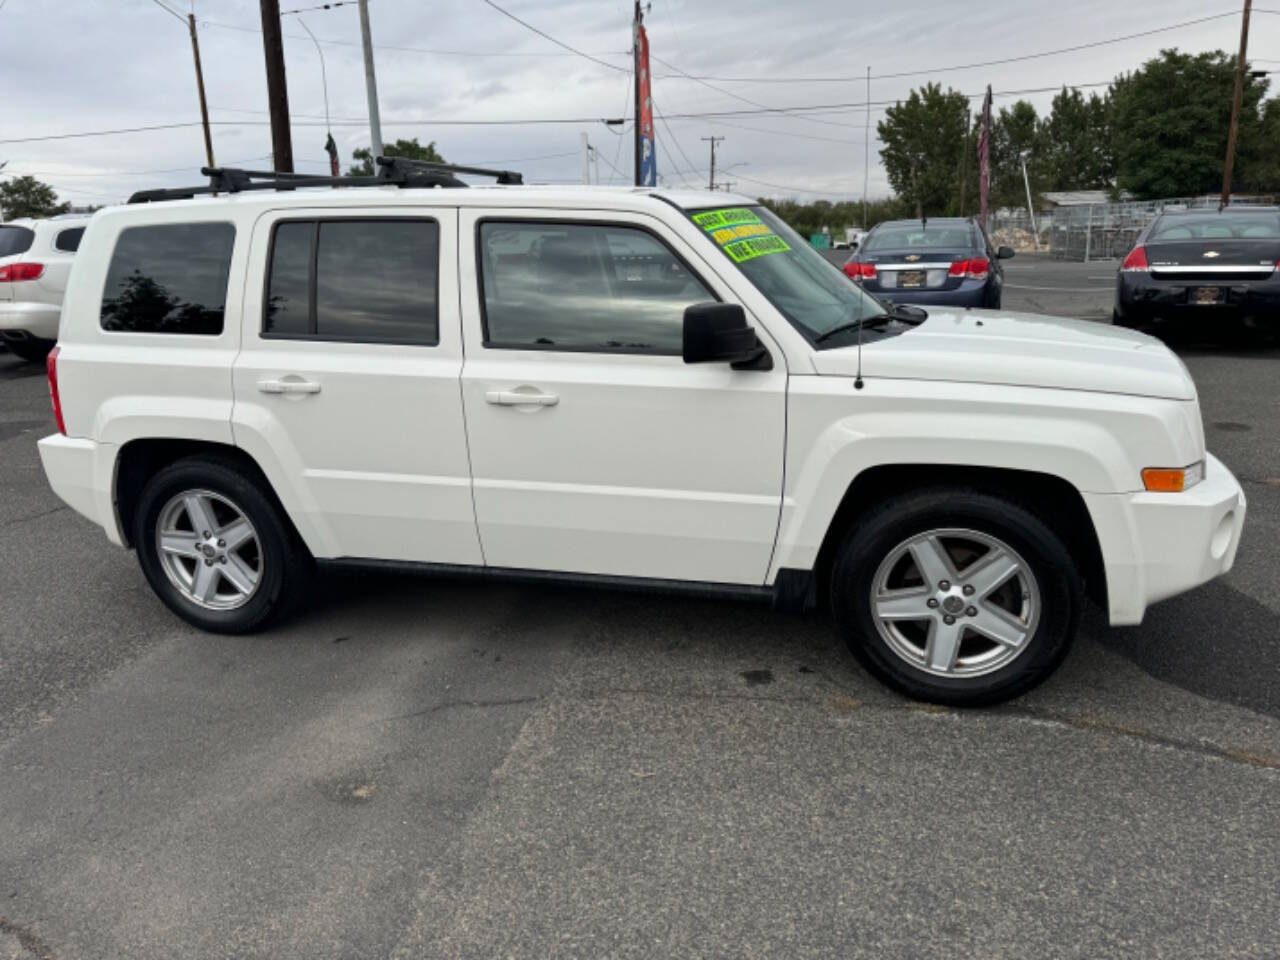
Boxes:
[132,456,315,634]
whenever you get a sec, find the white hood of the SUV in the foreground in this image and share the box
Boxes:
[814,307,1196,401]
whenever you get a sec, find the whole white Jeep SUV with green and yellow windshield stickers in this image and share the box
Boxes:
[40,164,1245,704]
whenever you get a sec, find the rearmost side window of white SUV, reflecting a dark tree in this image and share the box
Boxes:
[102,223,236,335]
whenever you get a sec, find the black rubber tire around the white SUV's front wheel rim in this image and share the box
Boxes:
[829,488,1083,707]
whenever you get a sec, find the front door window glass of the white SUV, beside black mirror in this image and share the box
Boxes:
[480,223,716,355]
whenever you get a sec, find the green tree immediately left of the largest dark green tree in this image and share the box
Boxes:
[1036,87,1115,189]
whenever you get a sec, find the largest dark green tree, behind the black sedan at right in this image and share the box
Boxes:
[1111,50,1267,200]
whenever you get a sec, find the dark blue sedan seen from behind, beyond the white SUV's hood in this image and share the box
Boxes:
[845,218,1014,310]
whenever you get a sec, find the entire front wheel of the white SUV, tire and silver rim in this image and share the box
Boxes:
[831,489,1082,707]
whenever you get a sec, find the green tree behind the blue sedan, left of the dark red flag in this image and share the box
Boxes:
[876,83,969,216]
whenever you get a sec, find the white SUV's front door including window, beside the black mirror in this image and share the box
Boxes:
[460,209,786,584]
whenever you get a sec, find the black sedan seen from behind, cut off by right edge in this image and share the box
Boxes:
[1114,206,1280,332]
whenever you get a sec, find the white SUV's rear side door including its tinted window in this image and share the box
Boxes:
[233,206,481,564]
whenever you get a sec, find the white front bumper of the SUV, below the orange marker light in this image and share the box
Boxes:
[1084,454,1245,626]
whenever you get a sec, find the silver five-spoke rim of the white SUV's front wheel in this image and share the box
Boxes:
[870,527,1041,677]
